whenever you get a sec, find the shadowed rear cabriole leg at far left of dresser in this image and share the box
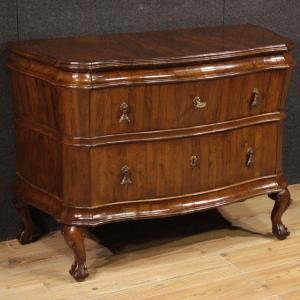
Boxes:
[13,197,41,245]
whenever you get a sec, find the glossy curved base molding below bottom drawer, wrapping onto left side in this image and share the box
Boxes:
[15,175,286,226]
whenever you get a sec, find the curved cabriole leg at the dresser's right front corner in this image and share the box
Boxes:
[269,188,291,240]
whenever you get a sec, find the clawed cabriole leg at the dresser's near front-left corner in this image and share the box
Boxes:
[62,225,89,281]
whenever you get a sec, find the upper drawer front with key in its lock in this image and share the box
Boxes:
[90,70,285,136]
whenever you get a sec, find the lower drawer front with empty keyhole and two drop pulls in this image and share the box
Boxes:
[91,123,277,206]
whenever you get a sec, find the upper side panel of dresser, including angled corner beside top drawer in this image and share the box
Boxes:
[10,70,90,137]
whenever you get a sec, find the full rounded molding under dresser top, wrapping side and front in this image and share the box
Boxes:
[6,53,290,89]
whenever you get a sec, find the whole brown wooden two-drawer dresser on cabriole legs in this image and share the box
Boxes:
[7,25,294,280]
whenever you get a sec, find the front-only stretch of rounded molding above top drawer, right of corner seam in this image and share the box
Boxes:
[91,55,289,88]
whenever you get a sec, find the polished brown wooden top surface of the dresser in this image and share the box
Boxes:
[10,24,293,70]
